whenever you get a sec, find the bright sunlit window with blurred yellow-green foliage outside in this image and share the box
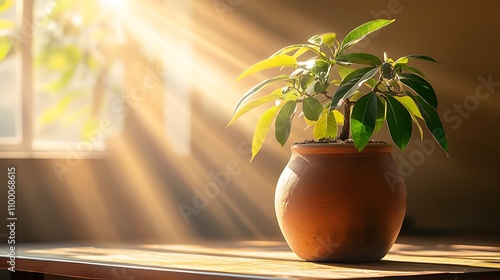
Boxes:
[0,0,126,156]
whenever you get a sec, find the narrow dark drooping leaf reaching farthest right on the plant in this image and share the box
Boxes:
[407,92,448,155]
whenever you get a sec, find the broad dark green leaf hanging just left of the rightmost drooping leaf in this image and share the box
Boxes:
[385,94,412,151]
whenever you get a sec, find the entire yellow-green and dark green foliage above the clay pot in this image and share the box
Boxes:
[229,19,448,159]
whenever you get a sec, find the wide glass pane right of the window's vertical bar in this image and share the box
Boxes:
[33,0,123,150]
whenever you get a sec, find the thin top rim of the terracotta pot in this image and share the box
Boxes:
[290,141,393,154]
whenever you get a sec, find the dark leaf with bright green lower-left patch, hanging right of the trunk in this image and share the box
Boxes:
[351,92,378,151]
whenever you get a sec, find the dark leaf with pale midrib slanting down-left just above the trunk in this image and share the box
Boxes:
[330,67,378,110]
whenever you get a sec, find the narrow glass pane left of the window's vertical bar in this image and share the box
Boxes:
[0,1,22,144]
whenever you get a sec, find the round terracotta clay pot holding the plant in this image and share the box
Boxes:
[275,143,406,262]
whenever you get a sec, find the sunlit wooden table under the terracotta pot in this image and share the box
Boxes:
[0,238,500,280]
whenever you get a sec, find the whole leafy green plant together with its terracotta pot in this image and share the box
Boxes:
[229,19,447,262]
